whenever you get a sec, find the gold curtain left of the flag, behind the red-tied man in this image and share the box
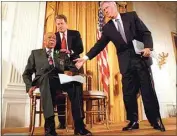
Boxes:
[45,1,98,90]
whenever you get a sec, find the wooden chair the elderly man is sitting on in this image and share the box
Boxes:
[29,89,68,136]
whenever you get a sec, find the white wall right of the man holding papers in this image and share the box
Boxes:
[133,2,177,119]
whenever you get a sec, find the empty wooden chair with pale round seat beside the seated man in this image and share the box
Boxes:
[83,72,109,129]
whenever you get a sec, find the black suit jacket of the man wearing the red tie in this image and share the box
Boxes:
[55,30,83,59]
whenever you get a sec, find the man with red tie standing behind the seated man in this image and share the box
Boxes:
[55,14,83,129]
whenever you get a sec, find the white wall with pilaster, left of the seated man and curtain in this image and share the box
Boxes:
[2,2,46,127]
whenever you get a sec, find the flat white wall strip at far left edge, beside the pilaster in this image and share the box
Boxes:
[2,2,17,98]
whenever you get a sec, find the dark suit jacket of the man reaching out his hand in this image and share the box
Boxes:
[86,11,153,74]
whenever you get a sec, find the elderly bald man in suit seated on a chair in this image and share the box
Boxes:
[23,33,91,136]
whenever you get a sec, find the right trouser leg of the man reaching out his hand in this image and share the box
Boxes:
[137,62,160,124]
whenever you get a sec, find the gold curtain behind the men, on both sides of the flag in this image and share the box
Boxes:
[45,1,141,122]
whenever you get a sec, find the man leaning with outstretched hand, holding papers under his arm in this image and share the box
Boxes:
[75,2,165,131]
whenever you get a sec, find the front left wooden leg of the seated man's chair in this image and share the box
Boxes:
[30,95,36,136]
